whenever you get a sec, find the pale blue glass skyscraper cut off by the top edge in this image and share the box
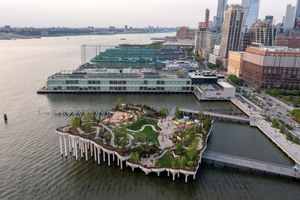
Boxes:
[242,0,260,29]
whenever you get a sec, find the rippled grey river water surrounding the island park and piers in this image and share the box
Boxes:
[0,34,300,199]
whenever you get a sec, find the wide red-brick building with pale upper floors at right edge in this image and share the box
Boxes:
[242,44,300,89]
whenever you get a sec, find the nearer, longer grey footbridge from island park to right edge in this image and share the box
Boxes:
[202,151,300,179]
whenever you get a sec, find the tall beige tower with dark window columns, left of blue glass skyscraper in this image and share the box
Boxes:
[220,5,244,62]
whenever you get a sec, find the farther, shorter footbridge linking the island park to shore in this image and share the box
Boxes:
[179,108,250,123]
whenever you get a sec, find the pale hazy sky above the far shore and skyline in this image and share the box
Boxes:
[0,0,296,28]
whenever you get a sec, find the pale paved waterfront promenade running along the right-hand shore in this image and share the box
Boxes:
[231,98,300,166]
